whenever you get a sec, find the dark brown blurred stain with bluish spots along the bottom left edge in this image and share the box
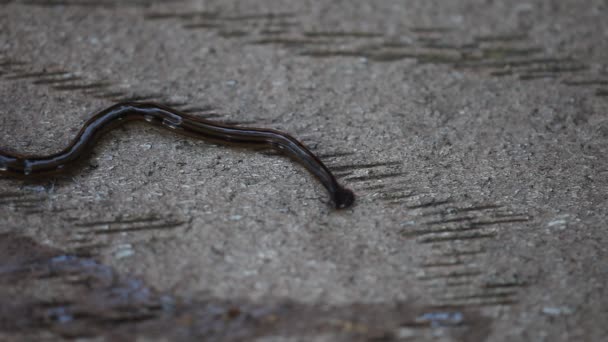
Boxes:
[0,234,489,341]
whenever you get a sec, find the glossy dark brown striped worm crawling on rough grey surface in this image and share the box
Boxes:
[0,102,355,209]
